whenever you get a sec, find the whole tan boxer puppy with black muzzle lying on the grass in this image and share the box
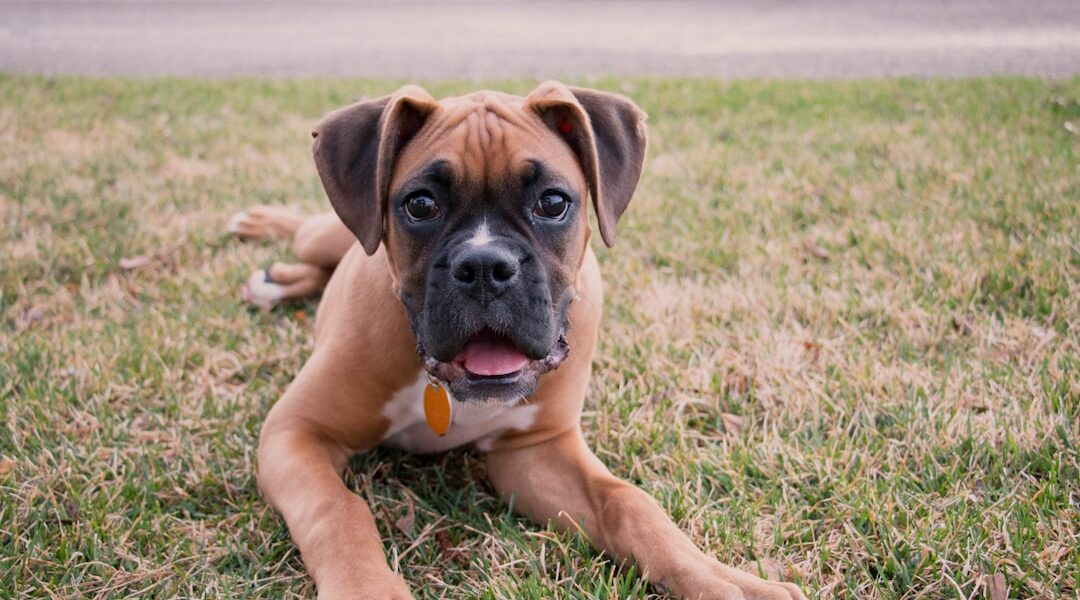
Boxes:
[230,82,805,600]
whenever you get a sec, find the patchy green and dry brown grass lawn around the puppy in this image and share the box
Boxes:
[0,76,1080,598]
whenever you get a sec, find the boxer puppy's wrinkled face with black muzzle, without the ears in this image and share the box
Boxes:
[386,94,589,400]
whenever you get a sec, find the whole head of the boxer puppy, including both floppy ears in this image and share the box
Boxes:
[313,82,646,403]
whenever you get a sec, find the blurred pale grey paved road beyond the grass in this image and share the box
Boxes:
[0,0,1080,79]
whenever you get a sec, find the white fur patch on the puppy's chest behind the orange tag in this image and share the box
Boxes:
[381,371,540,452]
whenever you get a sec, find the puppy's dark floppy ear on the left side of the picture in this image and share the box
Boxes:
[311,85,438,255]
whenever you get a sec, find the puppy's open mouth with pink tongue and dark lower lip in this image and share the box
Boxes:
[418,329,569,395]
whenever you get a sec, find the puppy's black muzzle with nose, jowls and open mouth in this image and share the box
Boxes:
[413,233,569,401]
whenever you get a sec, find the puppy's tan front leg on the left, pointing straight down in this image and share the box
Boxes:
[258,373,413,600]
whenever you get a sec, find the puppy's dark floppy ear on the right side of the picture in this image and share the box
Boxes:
[525,81,647,246]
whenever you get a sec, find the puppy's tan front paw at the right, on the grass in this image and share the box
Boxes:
[658,559,807,600]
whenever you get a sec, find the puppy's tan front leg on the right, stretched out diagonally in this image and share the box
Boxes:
[487,429,806,600]
